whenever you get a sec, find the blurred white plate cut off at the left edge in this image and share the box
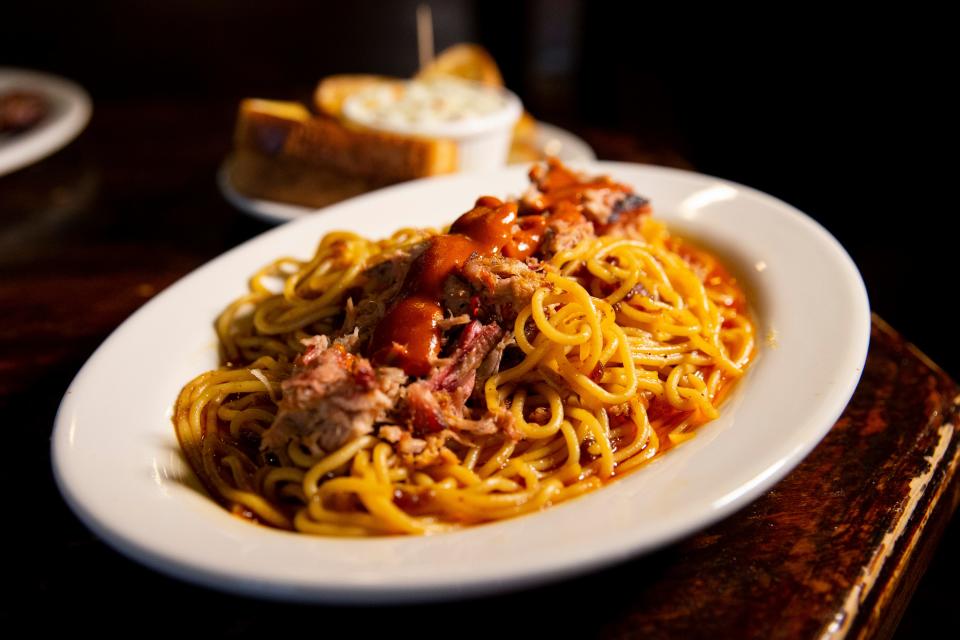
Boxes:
[0,67,91,176]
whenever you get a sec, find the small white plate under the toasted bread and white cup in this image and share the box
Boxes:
[217,122,597,224]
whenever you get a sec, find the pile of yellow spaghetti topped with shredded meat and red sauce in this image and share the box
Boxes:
[174,161,755,536]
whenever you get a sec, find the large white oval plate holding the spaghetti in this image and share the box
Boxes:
[52,162,870,603]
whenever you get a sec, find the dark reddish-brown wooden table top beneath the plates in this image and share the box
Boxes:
[0,100,960,638]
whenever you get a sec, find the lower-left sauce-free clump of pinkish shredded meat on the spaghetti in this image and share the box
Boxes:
[261,335,407,453]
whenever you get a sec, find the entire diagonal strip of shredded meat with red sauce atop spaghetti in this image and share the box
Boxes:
[262,161,657,468]
